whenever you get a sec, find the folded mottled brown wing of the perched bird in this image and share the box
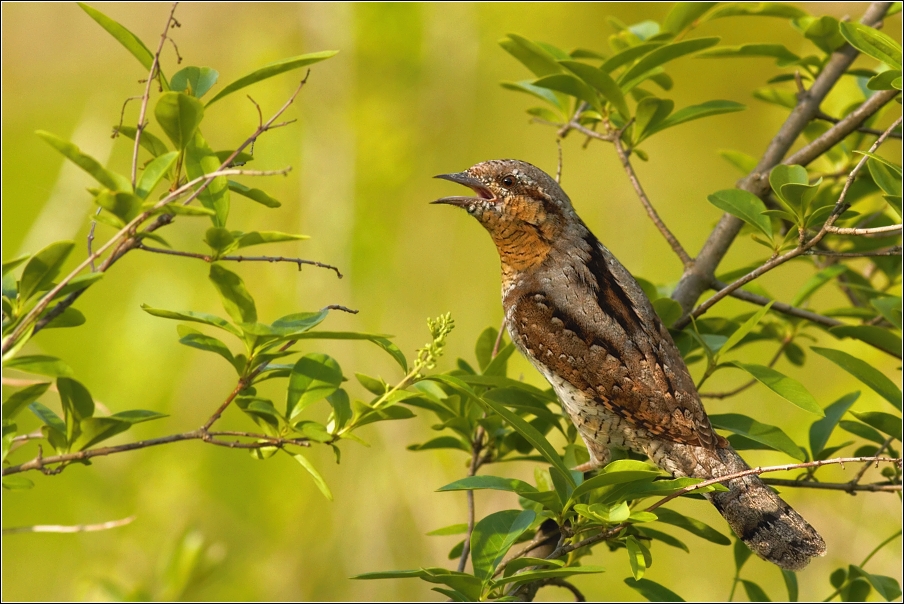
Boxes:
[509,240,719,449]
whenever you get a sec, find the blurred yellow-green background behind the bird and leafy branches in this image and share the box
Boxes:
[2,3,901,600]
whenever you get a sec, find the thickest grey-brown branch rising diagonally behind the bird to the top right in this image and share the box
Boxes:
[672,2,891,313]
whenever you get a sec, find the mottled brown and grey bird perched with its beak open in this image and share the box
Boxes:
[432,159,826,570]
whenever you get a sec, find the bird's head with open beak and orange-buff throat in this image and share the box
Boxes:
[433,159,577,270]
